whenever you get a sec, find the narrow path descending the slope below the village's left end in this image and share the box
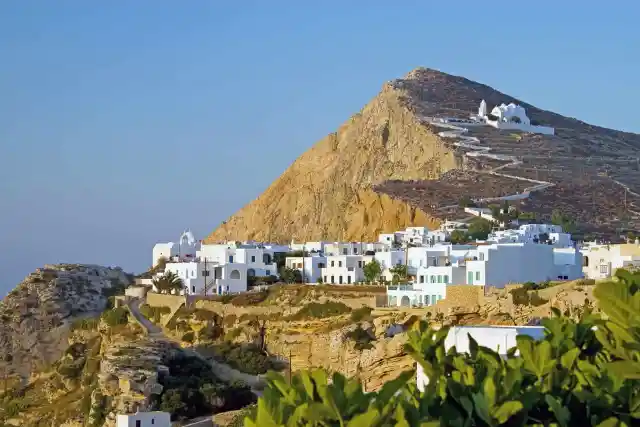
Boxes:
[127,298,264,397]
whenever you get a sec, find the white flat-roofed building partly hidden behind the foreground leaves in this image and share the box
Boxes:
[416,326,544,391]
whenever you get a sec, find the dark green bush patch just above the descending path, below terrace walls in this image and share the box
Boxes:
[198,341,277,375]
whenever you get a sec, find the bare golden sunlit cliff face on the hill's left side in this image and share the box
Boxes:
[207,84,457,246]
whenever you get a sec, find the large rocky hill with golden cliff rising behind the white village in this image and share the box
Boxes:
[207,68,640,242]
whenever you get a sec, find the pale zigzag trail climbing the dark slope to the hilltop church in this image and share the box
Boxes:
[425,117,555,210]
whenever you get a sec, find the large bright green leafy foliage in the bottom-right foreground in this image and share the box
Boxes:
[245,270,640,427]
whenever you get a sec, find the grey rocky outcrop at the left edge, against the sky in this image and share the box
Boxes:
[0,264,132,376]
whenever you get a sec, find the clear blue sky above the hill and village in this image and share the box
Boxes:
[0,0,640,295]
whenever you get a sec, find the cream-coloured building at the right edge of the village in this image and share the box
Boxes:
[580,243,640,279]
